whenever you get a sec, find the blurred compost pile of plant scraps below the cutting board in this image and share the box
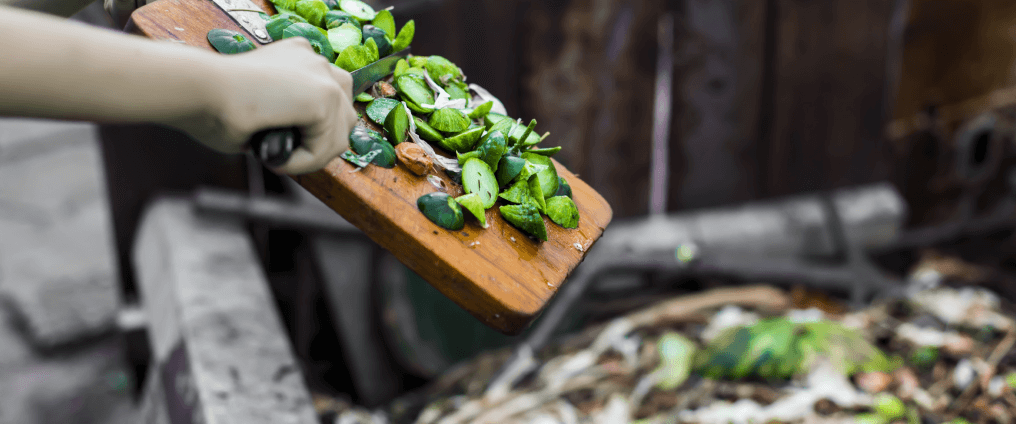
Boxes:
[321,249,1016,424]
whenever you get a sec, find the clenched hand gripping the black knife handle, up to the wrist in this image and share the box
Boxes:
[170,37,358,174]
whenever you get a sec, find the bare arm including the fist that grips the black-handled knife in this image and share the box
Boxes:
[0,7,357,173]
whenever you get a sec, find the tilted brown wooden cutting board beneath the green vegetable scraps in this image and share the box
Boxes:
[126,0,613,335]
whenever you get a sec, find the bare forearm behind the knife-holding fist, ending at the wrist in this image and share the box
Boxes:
[0,7,223,124]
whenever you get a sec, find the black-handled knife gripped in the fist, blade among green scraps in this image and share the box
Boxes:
[249,47,410,168]
